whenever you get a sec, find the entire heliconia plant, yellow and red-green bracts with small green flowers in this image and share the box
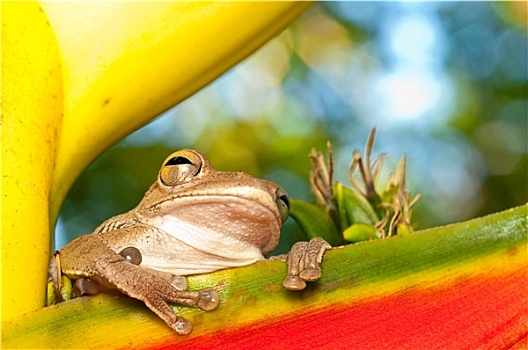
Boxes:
[1,2,528,349]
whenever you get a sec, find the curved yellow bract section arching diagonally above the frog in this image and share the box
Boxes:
[42,2,309,221]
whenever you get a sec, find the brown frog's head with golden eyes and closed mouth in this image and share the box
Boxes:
[138,149,289,254]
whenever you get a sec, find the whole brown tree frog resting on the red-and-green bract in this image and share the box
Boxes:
[51,149,330,334]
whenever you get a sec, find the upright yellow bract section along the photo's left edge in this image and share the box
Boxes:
[2,2,63,320]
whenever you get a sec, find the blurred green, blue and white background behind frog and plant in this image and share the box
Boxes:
[56,2,528,252]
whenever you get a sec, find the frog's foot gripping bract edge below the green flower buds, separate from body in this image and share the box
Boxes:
[283,237,332,290]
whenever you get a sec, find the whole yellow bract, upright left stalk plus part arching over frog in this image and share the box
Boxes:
[2,2,310,320]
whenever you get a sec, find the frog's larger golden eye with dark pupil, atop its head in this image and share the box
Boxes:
[159,150,202,186]
